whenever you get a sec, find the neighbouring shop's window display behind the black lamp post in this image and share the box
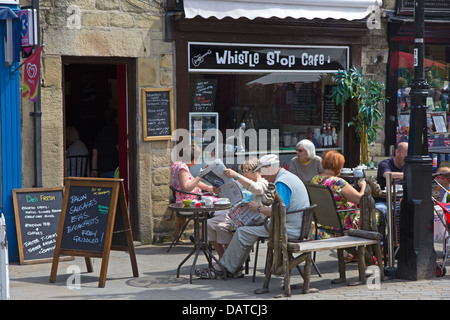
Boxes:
[385,0,450,154]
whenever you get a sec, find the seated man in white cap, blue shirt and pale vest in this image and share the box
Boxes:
[196,154,310,279]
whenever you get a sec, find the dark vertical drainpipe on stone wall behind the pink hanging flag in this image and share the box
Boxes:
[30,0,42,187]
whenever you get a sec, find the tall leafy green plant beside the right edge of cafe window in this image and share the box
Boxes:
[331,66,388,164]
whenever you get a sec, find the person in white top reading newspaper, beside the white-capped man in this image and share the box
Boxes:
[207,157,269,260]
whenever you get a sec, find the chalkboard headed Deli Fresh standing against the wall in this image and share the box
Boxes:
[12,187,64,264]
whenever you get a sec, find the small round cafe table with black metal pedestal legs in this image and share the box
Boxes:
[169,203,232,284]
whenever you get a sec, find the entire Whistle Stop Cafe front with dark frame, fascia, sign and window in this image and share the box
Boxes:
[165,1,376,169]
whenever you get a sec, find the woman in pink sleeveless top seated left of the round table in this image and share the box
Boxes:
[171,145,218,242]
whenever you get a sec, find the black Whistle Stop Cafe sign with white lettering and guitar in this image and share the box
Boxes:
[188,42,349,73]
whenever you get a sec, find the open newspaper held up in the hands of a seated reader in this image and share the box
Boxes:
[199,159,243,205]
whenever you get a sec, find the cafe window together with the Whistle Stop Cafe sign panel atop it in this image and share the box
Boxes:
[188,42,349,172]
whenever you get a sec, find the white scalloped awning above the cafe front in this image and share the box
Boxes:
[183,0,382,20]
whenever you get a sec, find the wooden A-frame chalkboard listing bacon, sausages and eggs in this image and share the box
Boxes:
[50,177,139,288]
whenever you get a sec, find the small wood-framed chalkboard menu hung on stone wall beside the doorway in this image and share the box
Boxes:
[142,88,174,141]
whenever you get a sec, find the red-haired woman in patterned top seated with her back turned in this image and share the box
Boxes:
[311,150,366,230]
